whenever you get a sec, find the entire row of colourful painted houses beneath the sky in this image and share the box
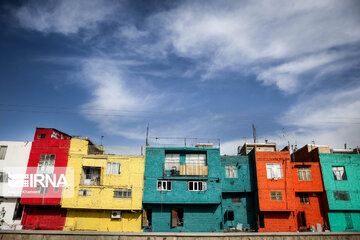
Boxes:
[0,128,360,232]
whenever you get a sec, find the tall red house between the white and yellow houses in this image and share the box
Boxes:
[21,128,71,230]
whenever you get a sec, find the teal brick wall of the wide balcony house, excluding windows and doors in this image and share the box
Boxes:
[143,147,222,232]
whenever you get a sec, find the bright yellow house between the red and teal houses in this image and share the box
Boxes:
[61,138,145,232]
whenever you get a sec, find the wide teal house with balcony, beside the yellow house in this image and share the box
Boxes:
[143,147,222,232]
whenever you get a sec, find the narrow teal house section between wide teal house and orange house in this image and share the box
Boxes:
[220,155,256,231]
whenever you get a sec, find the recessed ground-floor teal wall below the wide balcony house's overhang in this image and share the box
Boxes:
[144,204,222,232]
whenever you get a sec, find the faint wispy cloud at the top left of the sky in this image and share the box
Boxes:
[15,0,118,35]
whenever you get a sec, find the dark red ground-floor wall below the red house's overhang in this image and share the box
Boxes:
[21,205,66,230]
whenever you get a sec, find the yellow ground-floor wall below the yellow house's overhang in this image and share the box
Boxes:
[64,209,142,232]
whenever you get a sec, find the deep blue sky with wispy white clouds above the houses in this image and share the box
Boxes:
[0,0,360,154]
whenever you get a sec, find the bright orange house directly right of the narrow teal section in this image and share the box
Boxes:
[249,147,297,232]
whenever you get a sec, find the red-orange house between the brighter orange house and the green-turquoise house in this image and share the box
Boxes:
[291,145,329,231]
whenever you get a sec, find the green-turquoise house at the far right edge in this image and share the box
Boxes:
[320,150,360,232]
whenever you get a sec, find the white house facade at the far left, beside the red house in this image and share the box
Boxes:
[0,141,32,230]
